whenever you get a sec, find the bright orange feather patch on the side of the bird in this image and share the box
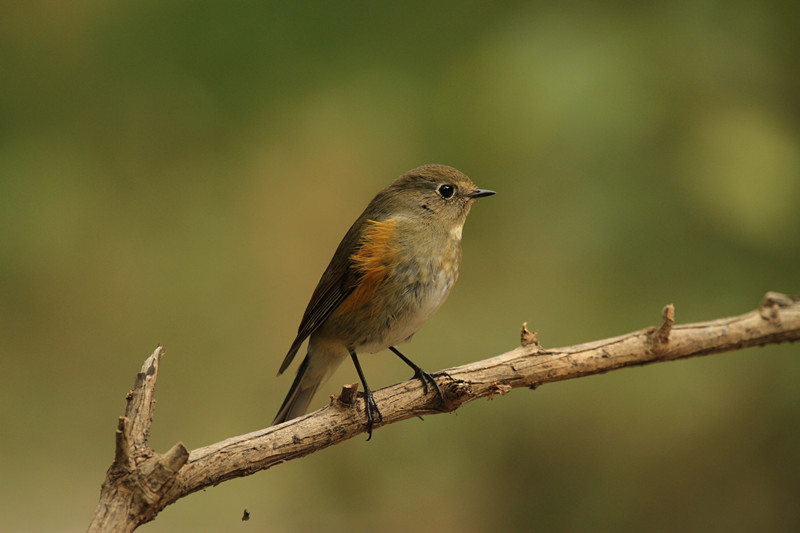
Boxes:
[339,219,397,311]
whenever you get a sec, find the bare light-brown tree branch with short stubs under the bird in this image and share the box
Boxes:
[89,293,800,532]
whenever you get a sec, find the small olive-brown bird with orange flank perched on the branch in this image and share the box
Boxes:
[272,165,495,440]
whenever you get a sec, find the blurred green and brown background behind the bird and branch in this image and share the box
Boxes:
[0,0,800,532]
